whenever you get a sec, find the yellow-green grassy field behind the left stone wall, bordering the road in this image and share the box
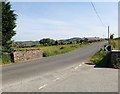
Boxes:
[15,43,92,57]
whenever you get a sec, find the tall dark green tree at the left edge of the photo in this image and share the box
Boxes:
[2,1,17,52]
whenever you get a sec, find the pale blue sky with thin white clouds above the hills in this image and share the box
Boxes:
[11,2,118,41]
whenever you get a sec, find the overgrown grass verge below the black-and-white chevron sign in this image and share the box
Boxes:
[90,49,120,69]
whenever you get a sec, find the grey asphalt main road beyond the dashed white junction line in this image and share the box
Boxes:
[2,42,105,91]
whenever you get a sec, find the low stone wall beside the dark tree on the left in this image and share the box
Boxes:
[13,49,43,62]
